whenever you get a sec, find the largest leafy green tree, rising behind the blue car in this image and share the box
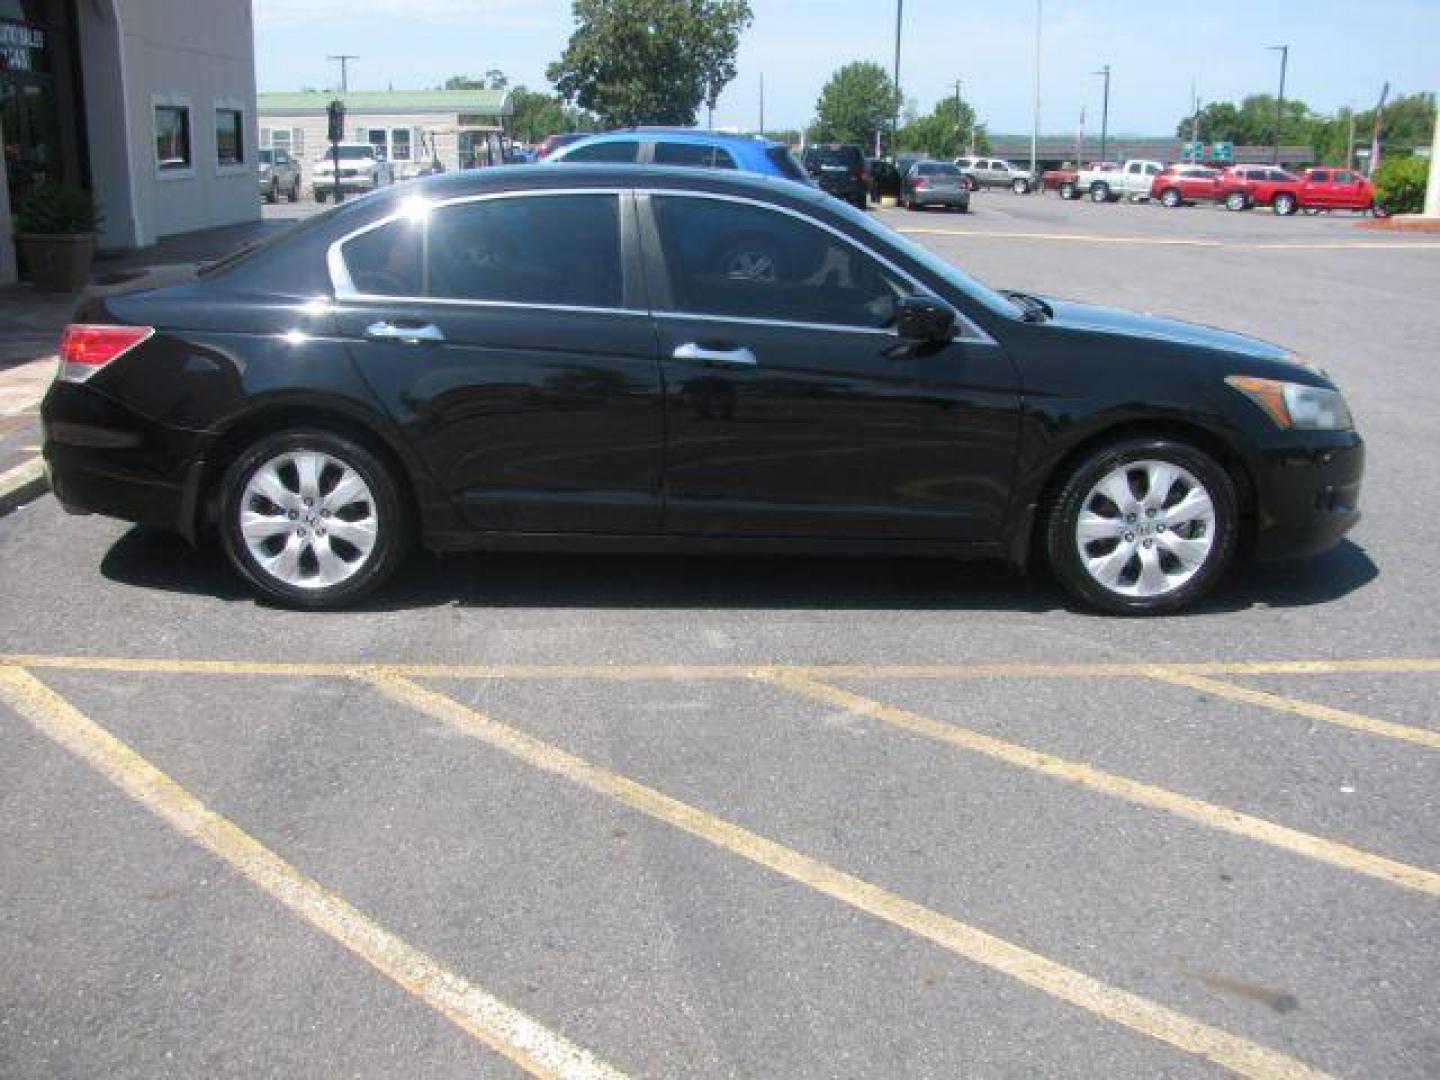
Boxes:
[546,0,752,127]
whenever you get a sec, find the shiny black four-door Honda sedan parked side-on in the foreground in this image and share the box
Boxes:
[43,166,1364,613]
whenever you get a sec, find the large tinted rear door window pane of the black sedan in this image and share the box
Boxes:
[426,194,624,308]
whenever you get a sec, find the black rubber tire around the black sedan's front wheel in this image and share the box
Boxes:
[1045,438,1240,615]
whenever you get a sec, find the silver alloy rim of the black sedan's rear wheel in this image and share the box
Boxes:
[239,449,380,589]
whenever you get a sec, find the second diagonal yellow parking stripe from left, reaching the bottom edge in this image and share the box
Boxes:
[357,671,1323,1079]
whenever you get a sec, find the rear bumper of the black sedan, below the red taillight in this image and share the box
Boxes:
[40,383,204,540]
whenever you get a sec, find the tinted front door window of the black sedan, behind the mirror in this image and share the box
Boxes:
[652,196,909,328]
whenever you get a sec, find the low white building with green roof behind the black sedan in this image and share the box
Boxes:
[258,89,511,179]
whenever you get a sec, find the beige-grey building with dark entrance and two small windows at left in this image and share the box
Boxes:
[0,0,259,281]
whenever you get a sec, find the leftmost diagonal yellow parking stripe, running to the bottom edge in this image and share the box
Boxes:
[0,665,624,1080]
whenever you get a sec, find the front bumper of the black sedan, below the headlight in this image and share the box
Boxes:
[1256,432,1365,559]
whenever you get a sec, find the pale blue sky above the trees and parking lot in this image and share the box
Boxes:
[255,0,1440,134]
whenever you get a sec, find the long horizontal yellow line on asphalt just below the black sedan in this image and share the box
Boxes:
[8,654,1440,681]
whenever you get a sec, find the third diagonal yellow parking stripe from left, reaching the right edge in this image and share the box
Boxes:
[766,670,1440,896]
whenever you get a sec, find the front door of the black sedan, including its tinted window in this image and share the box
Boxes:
[638,192,1018,541]
